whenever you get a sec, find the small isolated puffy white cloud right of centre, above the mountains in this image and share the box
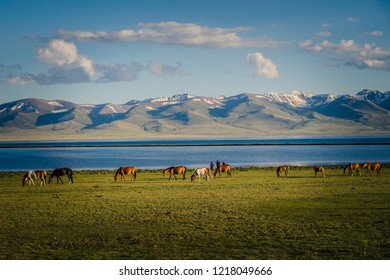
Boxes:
[246,52,279,79]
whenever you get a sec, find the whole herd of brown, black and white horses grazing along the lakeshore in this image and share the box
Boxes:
[22,162,382,186]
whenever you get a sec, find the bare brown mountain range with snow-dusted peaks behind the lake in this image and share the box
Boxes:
[0,90,390,140]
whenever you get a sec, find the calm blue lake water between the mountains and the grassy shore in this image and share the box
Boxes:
[0,137,390,171]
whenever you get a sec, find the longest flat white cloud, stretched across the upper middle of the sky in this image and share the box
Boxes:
[58,21,280,48]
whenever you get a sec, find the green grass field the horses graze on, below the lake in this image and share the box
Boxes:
[0,166,390,260]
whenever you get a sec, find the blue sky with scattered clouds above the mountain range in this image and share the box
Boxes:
[0,0,390,104]
